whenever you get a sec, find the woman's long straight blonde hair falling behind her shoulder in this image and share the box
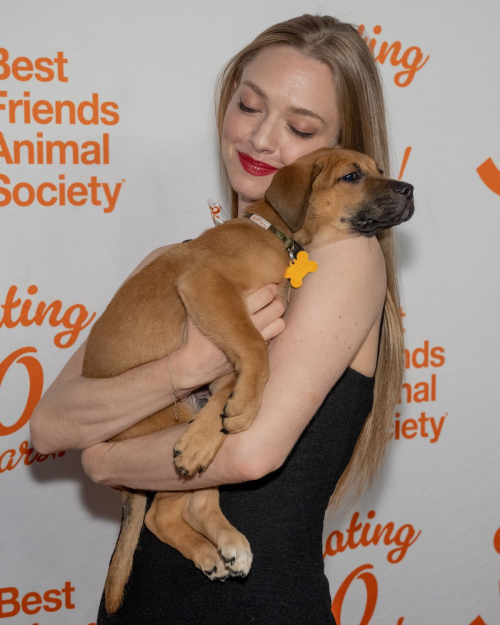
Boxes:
[215,15,405,511]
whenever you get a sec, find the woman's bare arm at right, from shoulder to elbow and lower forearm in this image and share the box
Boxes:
[82,237,386,490]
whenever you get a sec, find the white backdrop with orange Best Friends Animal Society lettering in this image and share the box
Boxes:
[0,0,500,625]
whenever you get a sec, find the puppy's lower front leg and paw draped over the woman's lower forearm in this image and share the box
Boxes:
[174,375,235,475]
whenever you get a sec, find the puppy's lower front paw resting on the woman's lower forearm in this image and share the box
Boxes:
[174,420,224,475]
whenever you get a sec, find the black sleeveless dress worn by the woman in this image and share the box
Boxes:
[97,369,374,625]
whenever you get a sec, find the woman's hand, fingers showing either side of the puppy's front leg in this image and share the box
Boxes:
[156,284,285,395]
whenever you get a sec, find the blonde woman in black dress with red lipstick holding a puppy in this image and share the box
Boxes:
[32,15,403,625]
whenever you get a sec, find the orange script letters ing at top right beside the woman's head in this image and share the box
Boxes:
[358,24,429,87]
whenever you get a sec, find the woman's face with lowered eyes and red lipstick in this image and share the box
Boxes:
[222,45,340,215]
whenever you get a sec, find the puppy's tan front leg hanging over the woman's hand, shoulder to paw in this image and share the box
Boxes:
[178,267,269,432]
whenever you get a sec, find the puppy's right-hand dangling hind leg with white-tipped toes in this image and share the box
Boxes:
[182,488,253,577]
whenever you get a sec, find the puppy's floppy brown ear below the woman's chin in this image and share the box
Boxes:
[265,161,323,232]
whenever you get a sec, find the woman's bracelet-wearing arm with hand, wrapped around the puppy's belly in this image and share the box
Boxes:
[30,248,284,454]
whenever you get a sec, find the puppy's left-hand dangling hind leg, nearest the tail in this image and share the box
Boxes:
[145,491,229,580]
